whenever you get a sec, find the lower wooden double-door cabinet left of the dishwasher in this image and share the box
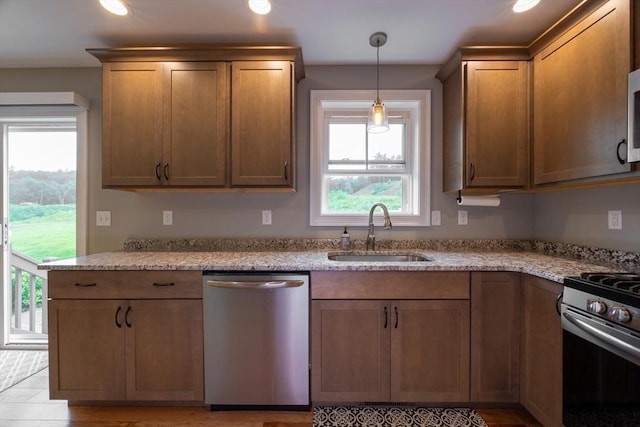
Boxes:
[49,272,204,402]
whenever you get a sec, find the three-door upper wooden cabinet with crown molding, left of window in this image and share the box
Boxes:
[89,46,304,191]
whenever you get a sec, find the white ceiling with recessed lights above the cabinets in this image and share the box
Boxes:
[0,0,580,68]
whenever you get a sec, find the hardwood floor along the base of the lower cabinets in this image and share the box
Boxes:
[0,369,540,427]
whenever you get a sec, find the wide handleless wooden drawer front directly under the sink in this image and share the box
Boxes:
[311,271,470,299]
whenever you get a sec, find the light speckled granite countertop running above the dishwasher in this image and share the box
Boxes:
[38,249,611,283]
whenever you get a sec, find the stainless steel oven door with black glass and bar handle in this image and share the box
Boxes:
[562,305,640,427]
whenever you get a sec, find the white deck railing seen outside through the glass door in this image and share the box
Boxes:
[11,250,49,334]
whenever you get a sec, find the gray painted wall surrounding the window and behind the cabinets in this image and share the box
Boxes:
[0,66,596,253]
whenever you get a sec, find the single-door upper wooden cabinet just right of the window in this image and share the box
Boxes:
[437,48,529,192]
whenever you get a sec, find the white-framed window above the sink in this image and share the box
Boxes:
[310,90,431,226]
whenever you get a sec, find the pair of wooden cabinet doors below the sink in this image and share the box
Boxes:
[311,300,469,402]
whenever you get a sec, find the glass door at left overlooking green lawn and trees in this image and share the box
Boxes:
[0,115,77,346]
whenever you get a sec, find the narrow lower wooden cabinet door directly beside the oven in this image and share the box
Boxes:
[521,275,562,426]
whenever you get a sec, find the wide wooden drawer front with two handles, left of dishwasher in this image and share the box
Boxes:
[49,270,202,299]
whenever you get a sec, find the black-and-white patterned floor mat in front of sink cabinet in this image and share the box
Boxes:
[313,406,487,427]
